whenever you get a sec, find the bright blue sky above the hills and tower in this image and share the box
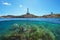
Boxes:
[0,0,60,16]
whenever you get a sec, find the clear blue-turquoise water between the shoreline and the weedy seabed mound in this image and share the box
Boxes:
[0,18,60,40]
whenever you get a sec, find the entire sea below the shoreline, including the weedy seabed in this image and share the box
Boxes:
[0,18,60,40]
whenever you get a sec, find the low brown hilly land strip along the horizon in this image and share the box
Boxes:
[1,14,60,18]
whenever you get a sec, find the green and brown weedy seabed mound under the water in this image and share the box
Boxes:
[0,23,55,40]
